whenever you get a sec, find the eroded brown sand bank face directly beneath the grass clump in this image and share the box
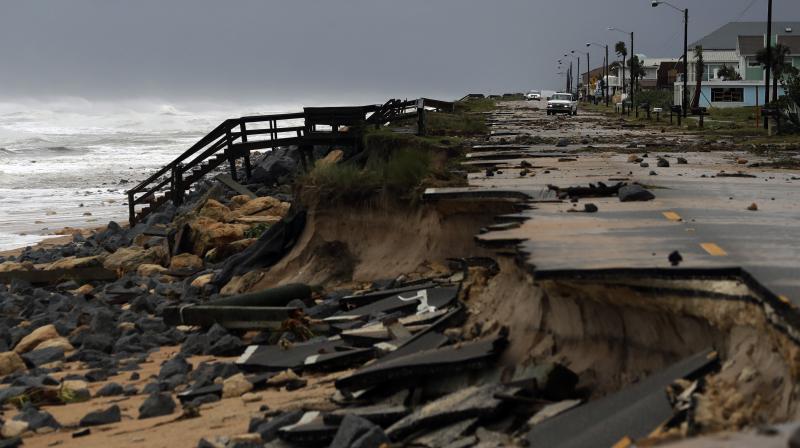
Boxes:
[251,197,515,291]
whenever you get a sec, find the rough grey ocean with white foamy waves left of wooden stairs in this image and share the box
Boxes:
[0,98,301,251]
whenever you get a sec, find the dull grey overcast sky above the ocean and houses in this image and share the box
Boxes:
[0,0,800,103]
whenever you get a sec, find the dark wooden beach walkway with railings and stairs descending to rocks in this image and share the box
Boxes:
[127,98,453,226]
